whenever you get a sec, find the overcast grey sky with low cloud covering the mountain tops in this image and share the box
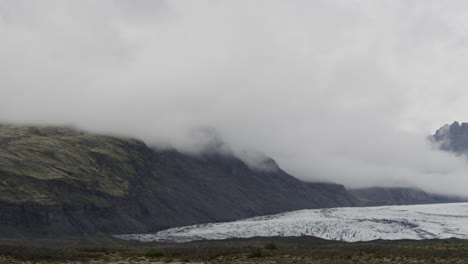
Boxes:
[0,0,468,194]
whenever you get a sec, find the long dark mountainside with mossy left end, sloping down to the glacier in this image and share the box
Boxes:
[0,125,355,236]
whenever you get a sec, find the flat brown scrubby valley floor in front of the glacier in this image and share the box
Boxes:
[0,237,468,264]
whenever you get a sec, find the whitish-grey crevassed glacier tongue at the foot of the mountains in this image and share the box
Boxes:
[116,203,468,242]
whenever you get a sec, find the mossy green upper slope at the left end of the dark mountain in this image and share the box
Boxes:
[0,125,145,206]
